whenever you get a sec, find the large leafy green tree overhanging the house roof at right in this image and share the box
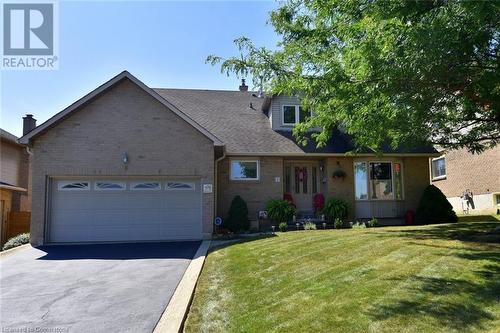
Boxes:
[207,0,500,152]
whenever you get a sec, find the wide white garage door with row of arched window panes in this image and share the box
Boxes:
[49,178,202,242]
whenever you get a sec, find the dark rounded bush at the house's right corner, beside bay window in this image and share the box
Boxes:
[415,185,458,224]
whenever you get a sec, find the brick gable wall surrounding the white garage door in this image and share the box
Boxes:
[31,79,214,244]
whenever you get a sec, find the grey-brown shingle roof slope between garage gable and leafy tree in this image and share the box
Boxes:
[153,89,436,155]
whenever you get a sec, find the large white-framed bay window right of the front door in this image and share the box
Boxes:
[354,161,404,200]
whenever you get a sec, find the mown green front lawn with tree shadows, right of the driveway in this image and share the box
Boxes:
[185,221,500,333]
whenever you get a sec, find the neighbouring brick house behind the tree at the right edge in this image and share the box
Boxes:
[431,146,500,214]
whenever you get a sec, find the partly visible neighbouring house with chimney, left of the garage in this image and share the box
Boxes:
[0,124,35,246]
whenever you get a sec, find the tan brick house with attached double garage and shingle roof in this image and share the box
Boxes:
[20,72,438,244]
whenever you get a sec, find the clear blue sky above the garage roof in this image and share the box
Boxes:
[0,1,278,136]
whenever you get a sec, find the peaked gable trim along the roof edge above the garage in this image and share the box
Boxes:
[19,71,223,146]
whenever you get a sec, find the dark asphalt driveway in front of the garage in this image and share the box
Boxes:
[0,242,200,332]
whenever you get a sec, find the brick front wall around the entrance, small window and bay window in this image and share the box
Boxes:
[217,156,430,226]
